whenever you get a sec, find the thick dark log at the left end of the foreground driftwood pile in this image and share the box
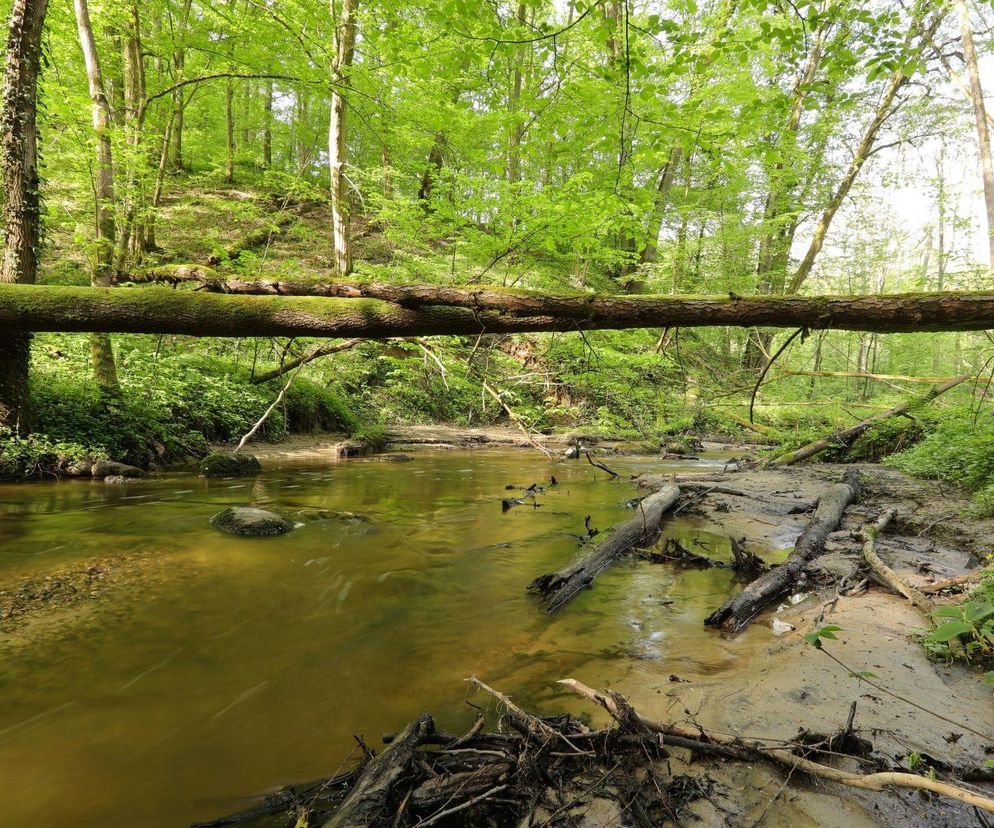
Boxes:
[324,713,435,828]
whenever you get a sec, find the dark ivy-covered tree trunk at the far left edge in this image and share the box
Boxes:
[0,0,48,434]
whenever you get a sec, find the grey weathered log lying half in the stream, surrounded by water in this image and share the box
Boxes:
[528,485,680,613]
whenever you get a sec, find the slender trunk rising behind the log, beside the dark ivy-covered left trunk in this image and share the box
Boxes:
[73,0,119,394]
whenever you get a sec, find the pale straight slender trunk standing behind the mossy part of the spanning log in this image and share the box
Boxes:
[328,0,357,276]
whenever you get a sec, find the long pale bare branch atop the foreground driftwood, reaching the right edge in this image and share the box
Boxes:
[558,679,994,813]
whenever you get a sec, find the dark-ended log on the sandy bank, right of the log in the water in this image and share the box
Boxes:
[704,469,860,632]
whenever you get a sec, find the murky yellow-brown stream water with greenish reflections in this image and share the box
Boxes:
[0,450,771,826]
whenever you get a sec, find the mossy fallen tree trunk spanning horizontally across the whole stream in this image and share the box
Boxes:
[0,280,994,339]
